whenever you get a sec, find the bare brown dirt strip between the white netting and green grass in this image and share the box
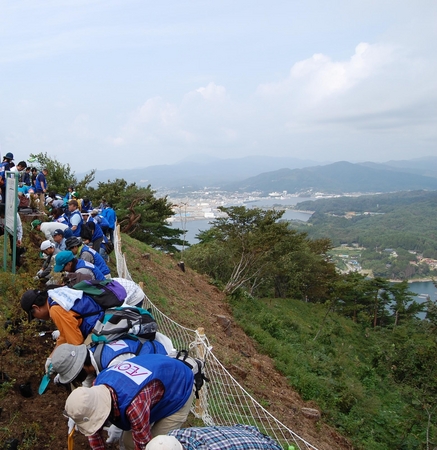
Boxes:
[118,236,352,450]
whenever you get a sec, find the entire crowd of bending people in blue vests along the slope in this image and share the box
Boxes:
[0,153,281,450]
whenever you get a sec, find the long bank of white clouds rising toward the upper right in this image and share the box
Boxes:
[99,32,435,165]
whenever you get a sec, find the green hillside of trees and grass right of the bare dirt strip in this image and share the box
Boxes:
[185,207,437,450]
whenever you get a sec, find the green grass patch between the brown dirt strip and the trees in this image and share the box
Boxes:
[231,296,435,450]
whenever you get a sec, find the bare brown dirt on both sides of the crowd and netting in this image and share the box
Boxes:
[0,232,353,450]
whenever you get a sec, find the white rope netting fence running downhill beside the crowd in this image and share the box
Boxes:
[114,227,317,450]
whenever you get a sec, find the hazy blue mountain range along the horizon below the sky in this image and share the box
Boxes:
[83,156,437,194]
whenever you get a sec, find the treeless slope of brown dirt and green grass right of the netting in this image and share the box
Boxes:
[117,237,434,450]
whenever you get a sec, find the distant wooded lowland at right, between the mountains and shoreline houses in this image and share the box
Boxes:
[292,191,437,279]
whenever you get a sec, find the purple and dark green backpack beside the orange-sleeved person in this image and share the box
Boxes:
[72,279,127,309]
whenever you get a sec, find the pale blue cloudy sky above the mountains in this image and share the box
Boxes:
[0,0,437,172]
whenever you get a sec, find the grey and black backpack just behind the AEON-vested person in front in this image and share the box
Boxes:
[91,306,158,342]
